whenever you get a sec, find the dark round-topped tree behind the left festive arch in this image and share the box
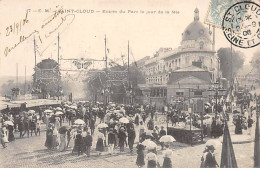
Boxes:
[33,58,62,98]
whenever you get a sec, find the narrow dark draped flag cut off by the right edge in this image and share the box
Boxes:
[254,116,260,168]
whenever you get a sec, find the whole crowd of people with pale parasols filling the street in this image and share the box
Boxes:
[0,91,255,168]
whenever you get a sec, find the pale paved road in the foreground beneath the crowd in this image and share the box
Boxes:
[0,114,254,168]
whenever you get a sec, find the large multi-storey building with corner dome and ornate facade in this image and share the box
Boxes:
[139,8,221,108]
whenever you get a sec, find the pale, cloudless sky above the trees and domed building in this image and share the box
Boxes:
[0,0,258,79]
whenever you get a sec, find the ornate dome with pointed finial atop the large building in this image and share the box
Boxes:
[182,8,210,41]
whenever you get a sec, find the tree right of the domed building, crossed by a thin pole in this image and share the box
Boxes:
[217,48,245,81]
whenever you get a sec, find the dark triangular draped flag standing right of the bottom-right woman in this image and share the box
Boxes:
[220,121,237,168]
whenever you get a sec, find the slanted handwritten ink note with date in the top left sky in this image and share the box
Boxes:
[1,7,75,57]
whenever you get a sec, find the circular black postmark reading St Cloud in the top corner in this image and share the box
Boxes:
[222,1,260,48]
